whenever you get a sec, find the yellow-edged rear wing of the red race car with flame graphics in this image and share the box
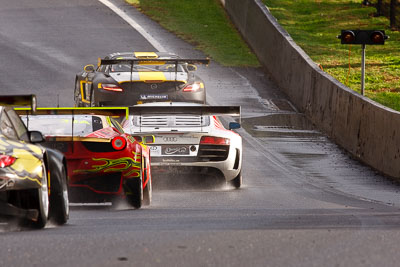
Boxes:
[14,107,129,117]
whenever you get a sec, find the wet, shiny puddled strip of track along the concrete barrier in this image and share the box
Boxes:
[242,111,400,206]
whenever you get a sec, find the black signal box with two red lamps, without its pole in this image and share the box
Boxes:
[338,30,389,45]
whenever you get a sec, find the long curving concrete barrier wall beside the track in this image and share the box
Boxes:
[222,0,400,178]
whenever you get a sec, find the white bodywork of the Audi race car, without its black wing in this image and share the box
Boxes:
[123,103,242,181]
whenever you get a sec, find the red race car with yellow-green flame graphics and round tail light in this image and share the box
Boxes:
[17,108,154,208]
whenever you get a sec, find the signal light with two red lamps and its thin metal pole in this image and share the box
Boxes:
[337,30,389,95]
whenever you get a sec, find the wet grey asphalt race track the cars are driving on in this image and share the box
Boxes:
[0,0,400,266]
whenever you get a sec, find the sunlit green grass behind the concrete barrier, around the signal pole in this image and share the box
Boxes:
[263,0,400,111]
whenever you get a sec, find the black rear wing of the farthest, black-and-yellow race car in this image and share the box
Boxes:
[98,58,210,66]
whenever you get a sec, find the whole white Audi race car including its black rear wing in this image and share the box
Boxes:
[122,102,242,188]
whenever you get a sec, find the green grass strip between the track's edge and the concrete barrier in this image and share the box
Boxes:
[126,0,259,67]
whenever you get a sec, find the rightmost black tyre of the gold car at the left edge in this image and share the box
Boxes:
[50,168,69,225]
